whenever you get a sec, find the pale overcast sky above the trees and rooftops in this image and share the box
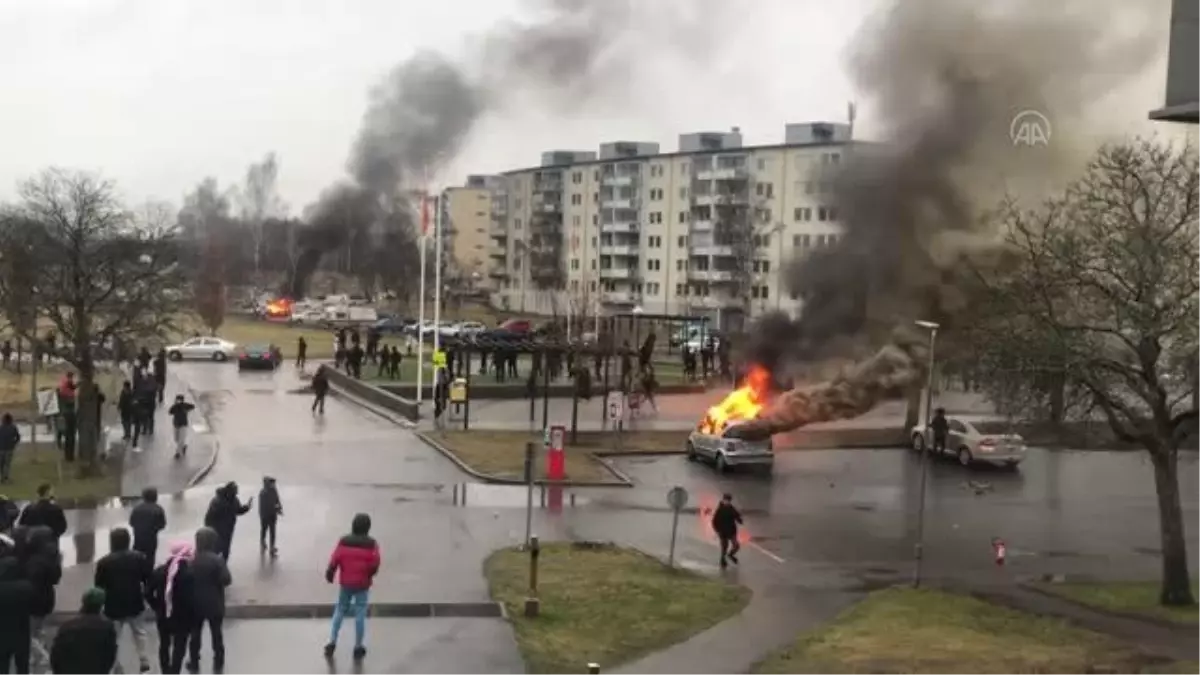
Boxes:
[0,0,1180,213]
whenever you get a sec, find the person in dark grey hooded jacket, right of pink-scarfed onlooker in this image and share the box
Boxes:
[187,527,233,673]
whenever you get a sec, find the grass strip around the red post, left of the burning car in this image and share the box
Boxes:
[433,431,688,483]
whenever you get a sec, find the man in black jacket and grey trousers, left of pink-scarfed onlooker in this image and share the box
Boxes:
[95,527,150,673]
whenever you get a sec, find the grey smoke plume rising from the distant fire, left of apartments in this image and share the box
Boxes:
[288,0,728,297]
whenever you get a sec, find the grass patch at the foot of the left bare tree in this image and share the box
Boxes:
[0,441,121,501]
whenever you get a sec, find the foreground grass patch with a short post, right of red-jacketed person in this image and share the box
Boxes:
[484,544,750,675]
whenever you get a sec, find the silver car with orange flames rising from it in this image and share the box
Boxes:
[688,366,775,473]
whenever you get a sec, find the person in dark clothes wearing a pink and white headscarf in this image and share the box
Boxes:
[146,542,197,675]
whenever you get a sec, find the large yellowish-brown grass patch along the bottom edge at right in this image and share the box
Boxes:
[754,589,1176,675]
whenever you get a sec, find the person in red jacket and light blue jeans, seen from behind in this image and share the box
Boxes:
[325,513,379,661]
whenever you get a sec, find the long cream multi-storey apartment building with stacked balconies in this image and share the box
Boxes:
[488,123,851,329]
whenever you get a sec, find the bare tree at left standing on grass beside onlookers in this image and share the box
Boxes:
[0,169,185,474]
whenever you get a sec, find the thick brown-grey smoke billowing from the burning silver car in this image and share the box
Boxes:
[729,0,1166,434]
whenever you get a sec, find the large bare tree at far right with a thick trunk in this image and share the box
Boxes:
[972,141,1200,605]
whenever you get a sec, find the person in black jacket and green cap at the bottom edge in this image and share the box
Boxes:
[50,589,116,675]
